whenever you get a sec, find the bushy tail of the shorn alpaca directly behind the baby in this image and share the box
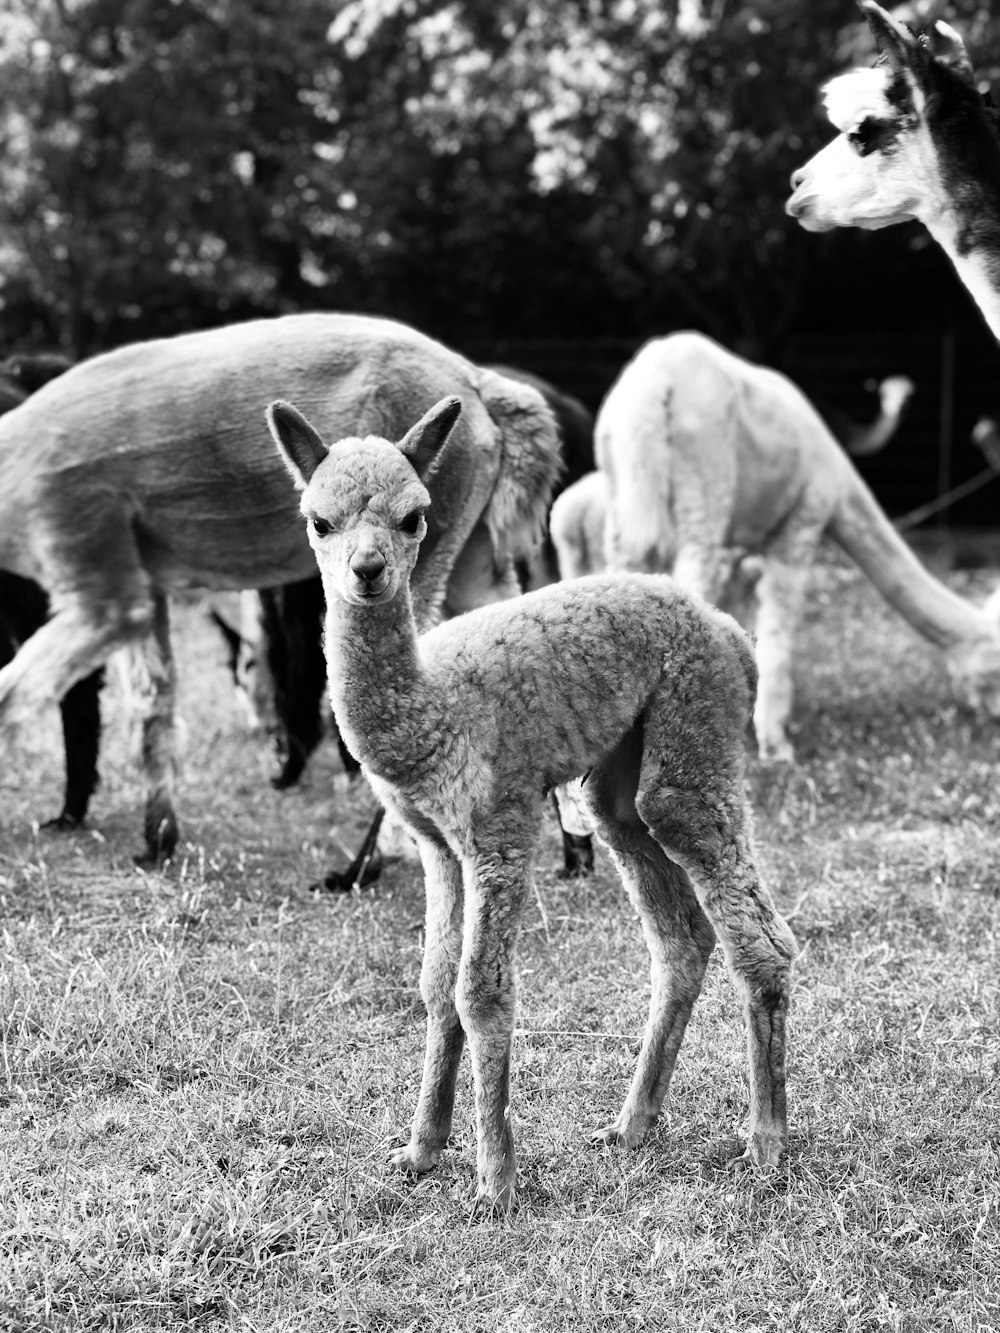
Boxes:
[479,371,563,563]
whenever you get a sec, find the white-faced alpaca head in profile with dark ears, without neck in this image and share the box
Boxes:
[785,0,992,232]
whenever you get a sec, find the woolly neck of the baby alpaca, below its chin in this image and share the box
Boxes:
[324,579,436,781]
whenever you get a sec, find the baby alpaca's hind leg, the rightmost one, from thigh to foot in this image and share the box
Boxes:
[636,709,795,1169]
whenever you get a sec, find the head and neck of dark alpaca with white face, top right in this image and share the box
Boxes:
[785,0,1000,339]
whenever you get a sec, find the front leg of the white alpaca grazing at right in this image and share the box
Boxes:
[753,540,813,762]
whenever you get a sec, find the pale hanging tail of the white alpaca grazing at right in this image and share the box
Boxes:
[595,380,676,571]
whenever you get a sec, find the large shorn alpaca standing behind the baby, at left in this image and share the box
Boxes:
[0,315,559,861]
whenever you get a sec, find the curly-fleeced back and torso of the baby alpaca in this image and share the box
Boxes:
[418,573,756,805]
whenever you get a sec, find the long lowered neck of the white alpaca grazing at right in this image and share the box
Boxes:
[828,469,992,652]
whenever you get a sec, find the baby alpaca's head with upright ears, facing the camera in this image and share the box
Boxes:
[267,397,461,605]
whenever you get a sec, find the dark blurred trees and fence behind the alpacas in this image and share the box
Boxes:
[0,0,1000,525]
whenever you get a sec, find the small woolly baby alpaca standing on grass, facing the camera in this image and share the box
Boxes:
[268,397,795,1209]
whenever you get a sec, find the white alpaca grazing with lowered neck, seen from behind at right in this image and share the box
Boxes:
[560,333,1000,761]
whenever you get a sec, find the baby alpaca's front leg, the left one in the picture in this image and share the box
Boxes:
[392,837,464,1173]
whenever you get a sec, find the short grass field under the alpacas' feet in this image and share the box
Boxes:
[0,535,1000,1333]
